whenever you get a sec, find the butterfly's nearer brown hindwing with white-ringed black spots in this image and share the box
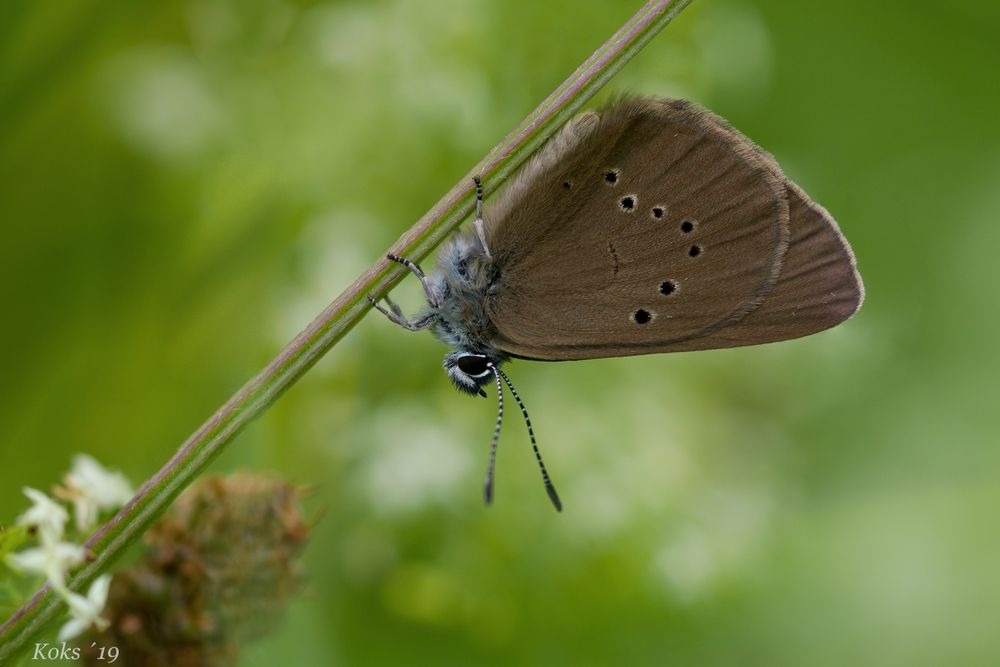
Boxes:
[487,99,789,360]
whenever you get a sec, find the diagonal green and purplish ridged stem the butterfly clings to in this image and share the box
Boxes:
[0,0,690,664]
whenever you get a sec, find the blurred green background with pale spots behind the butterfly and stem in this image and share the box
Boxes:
[0,0,1000,666]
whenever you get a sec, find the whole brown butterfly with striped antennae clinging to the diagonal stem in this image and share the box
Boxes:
[369,97,864,509]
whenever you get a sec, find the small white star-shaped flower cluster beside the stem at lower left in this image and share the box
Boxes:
[6,454,133,641]
